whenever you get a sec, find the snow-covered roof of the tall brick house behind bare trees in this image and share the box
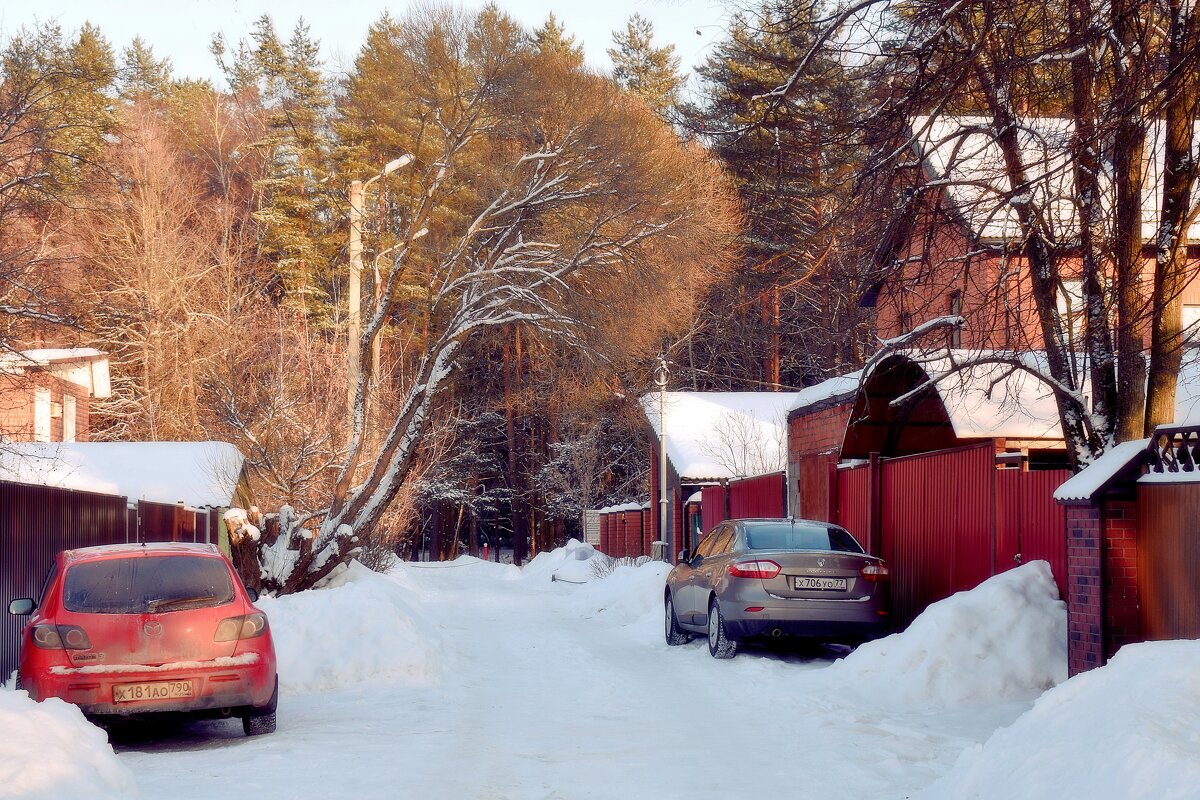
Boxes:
[912,116,1200,241]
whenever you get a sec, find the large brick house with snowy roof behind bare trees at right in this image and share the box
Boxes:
[868,116,1200,350]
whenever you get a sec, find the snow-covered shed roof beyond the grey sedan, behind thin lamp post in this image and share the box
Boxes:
[642,392,798,481]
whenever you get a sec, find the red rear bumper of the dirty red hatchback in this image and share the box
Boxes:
[23,657,275,716]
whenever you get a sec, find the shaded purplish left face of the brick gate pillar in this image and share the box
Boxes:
[1067,506,1104,675]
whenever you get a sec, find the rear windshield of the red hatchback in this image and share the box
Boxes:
[62,555,233,614]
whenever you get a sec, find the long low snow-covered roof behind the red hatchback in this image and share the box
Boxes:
[0,441,245,507]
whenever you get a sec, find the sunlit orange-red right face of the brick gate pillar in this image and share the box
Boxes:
[1104,500,1141,660]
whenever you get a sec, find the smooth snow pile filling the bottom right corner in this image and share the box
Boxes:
[920,640,1200,800]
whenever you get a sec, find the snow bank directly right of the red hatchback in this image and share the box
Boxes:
[258,561,440,692]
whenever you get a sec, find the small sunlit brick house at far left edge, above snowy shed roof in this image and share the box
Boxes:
[0,348,110,441]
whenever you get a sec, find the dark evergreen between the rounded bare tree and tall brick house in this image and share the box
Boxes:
[683,2,866,390]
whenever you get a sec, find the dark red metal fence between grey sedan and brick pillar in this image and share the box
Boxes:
[836,443,1069,628]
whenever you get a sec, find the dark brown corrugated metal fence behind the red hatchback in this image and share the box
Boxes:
[0,481,221,680]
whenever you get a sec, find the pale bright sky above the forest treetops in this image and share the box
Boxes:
[0,0,730,85]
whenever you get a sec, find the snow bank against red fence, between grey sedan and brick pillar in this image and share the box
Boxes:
[828,561,1067,705]
